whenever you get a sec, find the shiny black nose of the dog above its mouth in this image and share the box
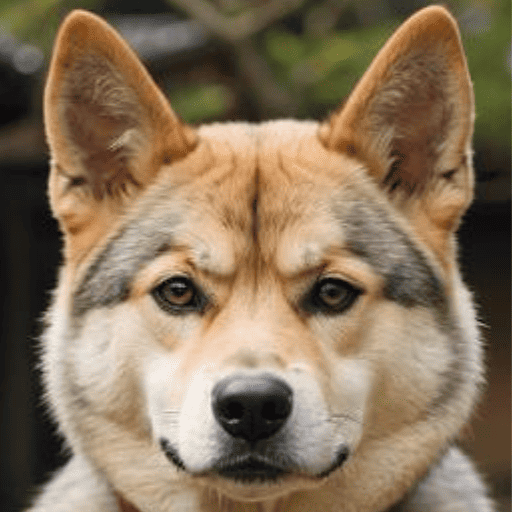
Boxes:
[212,375,293,442]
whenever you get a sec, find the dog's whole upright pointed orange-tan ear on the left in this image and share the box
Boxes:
[44,10,196,258]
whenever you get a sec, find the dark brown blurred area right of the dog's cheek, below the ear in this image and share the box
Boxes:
[460,203,511,512]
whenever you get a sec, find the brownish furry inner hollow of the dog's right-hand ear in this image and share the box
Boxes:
[376,60,457,196]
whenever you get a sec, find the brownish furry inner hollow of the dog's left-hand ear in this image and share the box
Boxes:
[61,54,145,199]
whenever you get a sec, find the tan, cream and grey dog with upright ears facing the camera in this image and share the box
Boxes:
[29,6,494,512]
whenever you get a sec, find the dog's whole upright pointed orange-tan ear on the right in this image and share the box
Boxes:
[320,6,474,237]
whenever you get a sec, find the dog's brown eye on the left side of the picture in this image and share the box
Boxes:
[151,276,206,314]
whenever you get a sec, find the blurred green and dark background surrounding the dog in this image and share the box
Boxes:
[0,0,511,512]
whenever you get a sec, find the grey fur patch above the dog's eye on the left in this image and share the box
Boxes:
[72,206,181,319]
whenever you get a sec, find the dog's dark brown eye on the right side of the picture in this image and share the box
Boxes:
[304,277,361,314]
